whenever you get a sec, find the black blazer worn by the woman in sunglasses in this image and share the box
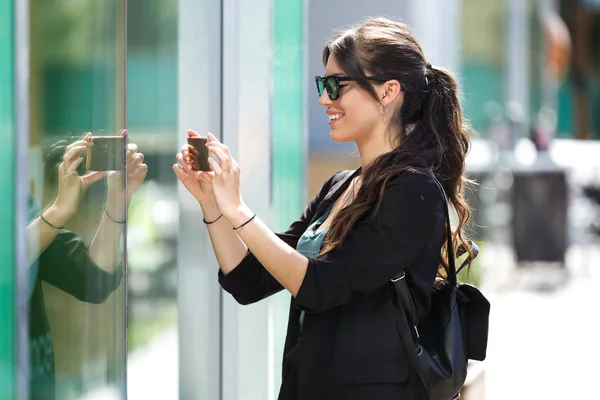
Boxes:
[219,169,445,400]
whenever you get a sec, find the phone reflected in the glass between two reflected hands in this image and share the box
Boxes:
[85,136,127,171]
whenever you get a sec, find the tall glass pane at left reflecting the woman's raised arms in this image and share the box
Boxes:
[27,0,129,399]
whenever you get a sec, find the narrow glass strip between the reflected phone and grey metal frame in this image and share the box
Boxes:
[127,0,179,400]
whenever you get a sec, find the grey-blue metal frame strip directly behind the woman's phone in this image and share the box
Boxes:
[173,0,222,400]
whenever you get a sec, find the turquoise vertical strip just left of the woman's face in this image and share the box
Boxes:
[270,0,304,394]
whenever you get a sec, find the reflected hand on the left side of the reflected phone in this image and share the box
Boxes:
[51,133,105,225]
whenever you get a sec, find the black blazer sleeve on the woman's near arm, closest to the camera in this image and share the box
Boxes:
[295,172,444,312]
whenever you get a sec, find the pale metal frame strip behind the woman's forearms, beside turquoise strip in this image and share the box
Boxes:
[220,0,273,400]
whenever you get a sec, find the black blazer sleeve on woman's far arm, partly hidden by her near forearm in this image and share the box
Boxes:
[218,171,342,305]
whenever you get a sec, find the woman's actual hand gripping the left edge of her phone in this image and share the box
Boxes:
[173,130,217,208]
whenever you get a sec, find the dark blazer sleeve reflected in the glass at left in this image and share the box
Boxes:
[39,231,123,304]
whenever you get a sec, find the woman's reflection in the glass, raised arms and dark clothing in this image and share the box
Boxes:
[27,132,148,399]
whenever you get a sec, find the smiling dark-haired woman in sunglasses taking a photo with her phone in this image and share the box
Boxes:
[174,18,470,400]
